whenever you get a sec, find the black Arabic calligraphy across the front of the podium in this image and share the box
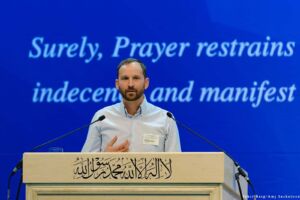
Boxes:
[73,157,172,180]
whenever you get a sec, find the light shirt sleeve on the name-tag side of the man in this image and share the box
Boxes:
[165,117,181,152]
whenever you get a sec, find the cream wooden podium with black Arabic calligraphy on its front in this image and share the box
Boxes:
[23,152,247,200]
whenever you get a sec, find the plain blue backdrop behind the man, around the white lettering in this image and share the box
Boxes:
[0,0,300,199]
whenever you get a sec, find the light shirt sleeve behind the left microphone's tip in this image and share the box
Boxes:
[81,113,102,152]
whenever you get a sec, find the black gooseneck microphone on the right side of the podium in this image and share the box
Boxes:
[167,112,256,199]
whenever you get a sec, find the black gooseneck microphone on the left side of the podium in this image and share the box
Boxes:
[7,115,105,200]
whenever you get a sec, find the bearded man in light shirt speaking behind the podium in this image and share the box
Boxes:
[82,58,181,152]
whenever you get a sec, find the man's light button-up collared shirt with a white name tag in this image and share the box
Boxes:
[82,98,181,152]
